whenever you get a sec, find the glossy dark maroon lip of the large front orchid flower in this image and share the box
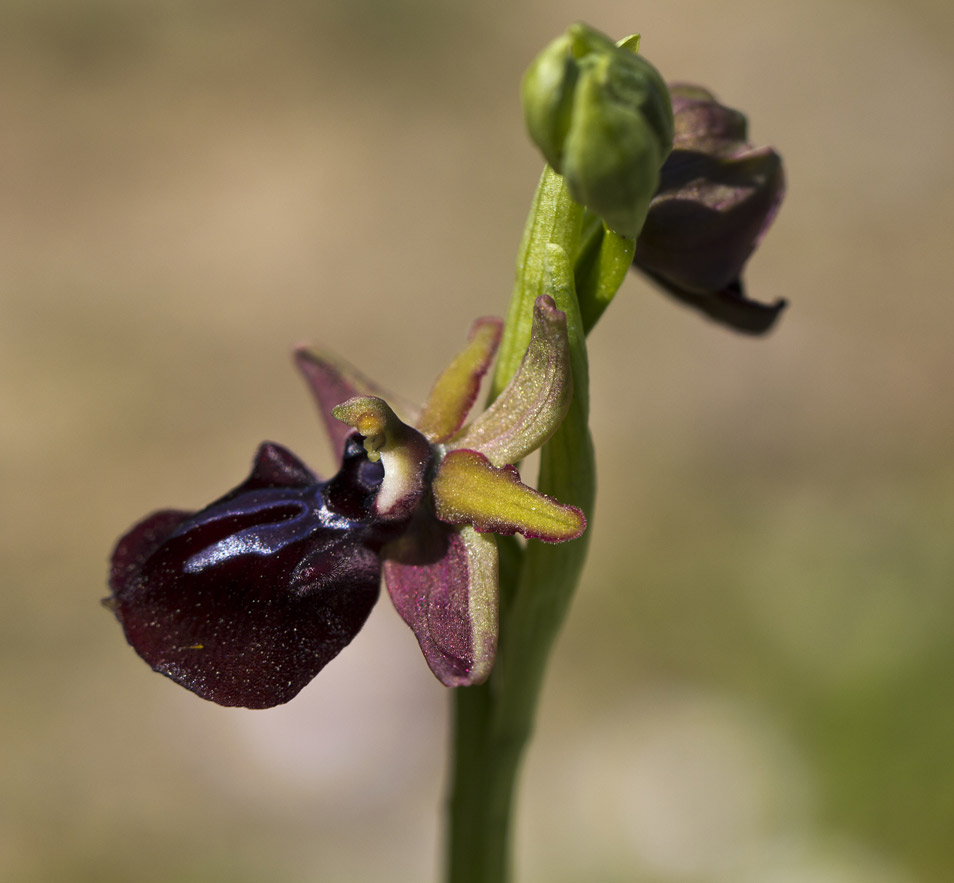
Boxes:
[106,438,404,708]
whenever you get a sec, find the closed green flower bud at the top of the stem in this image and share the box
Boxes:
[523,24,673,239]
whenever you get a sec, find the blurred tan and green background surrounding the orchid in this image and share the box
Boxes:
[0,0,954,883]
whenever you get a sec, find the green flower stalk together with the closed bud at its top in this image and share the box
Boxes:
[447,24,672,883]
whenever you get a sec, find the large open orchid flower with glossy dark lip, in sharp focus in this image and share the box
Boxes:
[105,296,586,708]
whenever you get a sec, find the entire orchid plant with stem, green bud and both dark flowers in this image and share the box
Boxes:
[105,23,785,883]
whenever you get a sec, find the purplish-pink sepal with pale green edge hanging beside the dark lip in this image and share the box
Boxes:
[384,508,498,687]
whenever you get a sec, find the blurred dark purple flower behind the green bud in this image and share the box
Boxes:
[634,84,785,334]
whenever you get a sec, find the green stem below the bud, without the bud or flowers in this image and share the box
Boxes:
[447,167,608,883]
